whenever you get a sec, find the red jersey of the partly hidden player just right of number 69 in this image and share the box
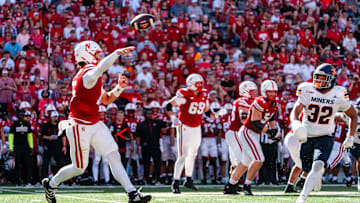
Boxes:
[229,97,252,132]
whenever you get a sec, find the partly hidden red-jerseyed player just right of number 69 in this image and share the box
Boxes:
[225,81,258,168]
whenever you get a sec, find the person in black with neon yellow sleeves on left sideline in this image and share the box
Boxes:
[9,110,34,185]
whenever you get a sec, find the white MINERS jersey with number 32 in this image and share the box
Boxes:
[296,82,351,137]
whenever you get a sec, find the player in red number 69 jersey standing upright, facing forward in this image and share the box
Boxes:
[166,74,210,193]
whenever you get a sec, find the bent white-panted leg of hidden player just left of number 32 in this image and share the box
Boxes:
[284,133,302,193]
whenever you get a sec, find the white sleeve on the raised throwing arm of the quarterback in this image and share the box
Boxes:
[83,51,120,89]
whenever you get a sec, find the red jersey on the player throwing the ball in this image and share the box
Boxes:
[69,64,102,123]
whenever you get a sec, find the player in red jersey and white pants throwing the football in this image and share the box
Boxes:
[42,41,151,203]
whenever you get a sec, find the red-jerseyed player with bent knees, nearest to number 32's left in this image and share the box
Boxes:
[224,80,278,195]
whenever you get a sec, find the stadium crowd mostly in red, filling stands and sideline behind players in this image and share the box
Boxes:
[0,0,360,187]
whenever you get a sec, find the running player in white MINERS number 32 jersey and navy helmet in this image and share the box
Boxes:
[290,63,357,203]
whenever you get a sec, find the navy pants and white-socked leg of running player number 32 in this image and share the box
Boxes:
[298,136,334,202]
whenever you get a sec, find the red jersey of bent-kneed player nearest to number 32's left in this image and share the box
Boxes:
[244,96,278,134]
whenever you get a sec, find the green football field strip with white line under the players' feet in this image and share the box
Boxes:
[0,185,360,203]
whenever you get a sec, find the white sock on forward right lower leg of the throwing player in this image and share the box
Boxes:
[106,151,136,193]
